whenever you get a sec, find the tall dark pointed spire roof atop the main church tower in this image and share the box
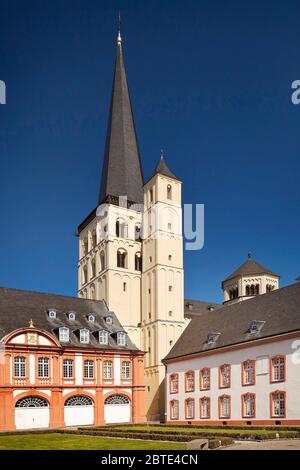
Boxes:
[99,27,144,204]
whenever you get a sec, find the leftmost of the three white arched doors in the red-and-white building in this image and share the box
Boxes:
[15,397,50,429]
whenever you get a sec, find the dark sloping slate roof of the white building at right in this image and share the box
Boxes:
[165,283,300,361]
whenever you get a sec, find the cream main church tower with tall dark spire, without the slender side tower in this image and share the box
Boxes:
[78,27,144,347]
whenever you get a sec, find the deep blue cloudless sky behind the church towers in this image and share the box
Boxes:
[0,0,300,301]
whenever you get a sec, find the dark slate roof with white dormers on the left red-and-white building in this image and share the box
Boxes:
[0,287,137,351]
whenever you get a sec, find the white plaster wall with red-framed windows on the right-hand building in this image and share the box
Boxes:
[166,335,300,421]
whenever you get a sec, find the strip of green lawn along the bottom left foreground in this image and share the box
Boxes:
[0,434,186,450]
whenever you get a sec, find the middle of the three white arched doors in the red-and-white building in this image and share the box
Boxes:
[65,395,94,426]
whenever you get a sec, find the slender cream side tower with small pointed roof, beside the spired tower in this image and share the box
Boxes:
[141,155,186,421]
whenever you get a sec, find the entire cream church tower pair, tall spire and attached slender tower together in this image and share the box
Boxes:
[78,33,186,420]
